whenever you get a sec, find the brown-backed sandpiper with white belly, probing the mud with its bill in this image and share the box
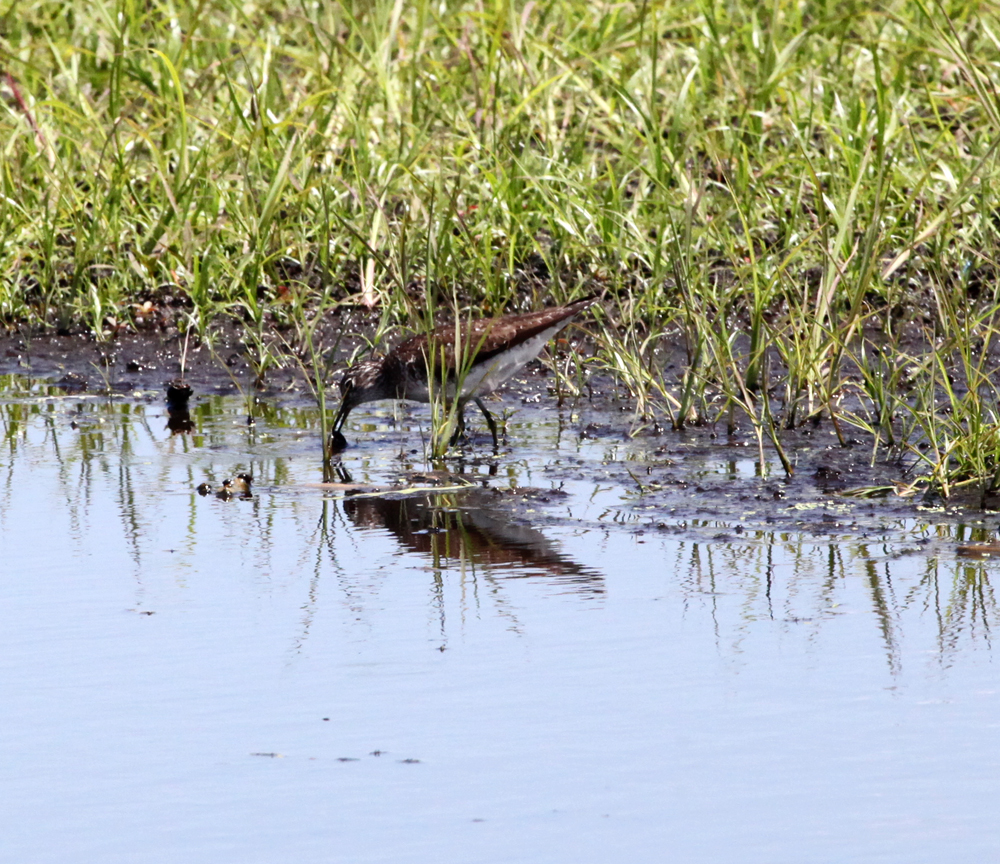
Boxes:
[330,297,597,453]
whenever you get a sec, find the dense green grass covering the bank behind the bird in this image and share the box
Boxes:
[0,0,1000,487]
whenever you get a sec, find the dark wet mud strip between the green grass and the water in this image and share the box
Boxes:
[0,334,1000,540]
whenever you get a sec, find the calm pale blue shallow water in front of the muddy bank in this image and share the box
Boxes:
[0,379,1000,864]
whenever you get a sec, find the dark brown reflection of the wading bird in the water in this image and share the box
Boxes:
[344,489,604,595]
